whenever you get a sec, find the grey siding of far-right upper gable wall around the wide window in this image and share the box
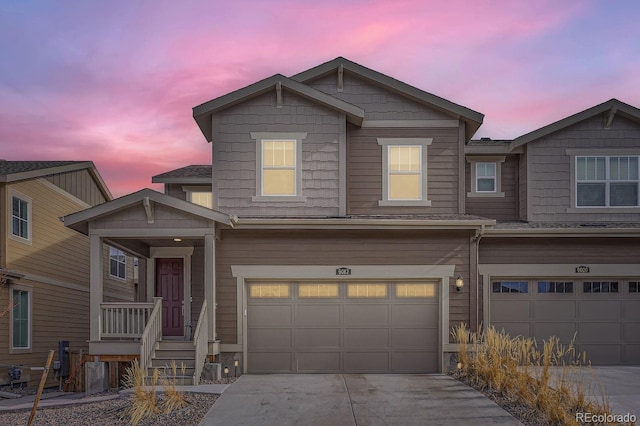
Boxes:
[527,115,640,222]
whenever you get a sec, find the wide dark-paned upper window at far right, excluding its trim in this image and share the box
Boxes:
[576,156,640,207]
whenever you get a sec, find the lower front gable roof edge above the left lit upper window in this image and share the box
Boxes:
[193,74,364,142]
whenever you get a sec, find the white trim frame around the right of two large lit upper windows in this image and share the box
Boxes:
[378,138,433,207]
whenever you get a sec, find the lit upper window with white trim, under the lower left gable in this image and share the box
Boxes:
[251,132,307,201]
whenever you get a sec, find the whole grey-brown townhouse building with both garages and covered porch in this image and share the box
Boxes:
[65,58,640,380]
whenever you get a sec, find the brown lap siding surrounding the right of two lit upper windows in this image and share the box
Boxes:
[347,126,459,214]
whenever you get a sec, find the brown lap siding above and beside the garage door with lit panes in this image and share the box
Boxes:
[216,230,469,343]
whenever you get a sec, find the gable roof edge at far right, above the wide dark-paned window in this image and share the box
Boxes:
[511,99,640,150]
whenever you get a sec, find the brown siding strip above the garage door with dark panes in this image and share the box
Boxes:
[480,238,640,264]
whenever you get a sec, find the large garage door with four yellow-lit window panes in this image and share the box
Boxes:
[247,282,438,373]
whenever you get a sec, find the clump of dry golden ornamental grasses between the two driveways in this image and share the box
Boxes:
[452,324,632,425]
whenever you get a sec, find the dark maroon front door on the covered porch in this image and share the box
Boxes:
[156,259,184,336]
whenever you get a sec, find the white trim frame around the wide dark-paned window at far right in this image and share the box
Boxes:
[565,148,640,213]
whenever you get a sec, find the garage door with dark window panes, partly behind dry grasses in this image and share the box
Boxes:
[490,279,640,365]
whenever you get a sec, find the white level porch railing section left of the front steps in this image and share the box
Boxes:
[100,303,153,339]
